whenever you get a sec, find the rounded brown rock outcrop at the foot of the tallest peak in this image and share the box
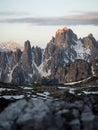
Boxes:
[65,60,92,82]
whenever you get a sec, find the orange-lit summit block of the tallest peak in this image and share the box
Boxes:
[54,27,77,47]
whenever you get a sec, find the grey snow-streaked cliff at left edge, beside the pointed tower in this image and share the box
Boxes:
[0,50,22,82]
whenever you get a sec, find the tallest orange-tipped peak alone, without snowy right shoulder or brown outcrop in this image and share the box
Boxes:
[40,28,77,79]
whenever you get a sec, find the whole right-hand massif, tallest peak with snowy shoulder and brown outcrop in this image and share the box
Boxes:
[40,27,98,82]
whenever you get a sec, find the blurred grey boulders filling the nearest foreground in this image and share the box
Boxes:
[0,93,98,130]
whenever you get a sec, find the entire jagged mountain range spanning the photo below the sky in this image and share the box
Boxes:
[0,27,98,84]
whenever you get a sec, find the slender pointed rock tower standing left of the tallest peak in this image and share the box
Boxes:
[12,41,39,83]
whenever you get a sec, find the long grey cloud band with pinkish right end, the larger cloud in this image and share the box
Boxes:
[0,12,98,26]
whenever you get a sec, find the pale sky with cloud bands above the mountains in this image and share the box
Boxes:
[0,0,98,48]
